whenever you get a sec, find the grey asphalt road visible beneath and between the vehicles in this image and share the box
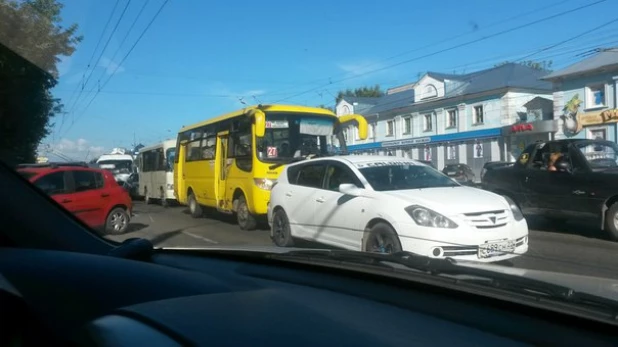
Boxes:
[109,202,618,279]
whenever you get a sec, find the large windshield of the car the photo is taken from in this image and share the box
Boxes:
[0,0,618,316]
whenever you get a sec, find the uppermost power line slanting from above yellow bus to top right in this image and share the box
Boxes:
[275,0,607,103]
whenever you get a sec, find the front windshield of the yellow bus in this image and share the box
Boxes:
[257,112,336,162]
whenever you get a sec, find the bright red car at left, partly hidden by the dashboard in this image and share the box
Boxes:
[17,163,132,234]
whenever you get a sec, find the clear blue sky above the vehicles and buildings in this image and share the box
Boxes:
[42,0,618,160]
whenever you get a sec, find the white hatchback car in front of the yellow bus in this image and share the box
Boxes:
[268,156,528,262]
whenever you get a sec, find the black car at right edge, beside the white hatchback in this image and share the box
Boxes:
[483,139,618,241]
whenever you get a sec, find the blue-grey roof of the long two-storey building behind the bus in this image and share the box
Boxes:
[356,63,552,115]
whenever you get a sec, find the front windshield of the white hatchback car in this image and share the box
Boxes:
[360,165,459,191]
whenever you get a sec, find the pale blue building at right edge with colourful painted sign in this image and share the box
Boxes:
[544,48,618,142]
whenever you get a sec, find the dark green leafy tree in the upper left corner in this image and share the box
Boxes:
[0,0,82,165]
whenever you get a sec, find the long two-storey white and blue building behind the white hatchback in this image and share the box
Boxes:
[336,64,555,177]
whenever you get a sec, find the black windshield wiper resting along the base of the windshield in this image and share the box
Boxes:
[271,250,618,320]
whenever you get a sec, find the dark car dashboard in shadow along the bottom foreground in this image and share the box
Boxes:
[0,248,618,346]
